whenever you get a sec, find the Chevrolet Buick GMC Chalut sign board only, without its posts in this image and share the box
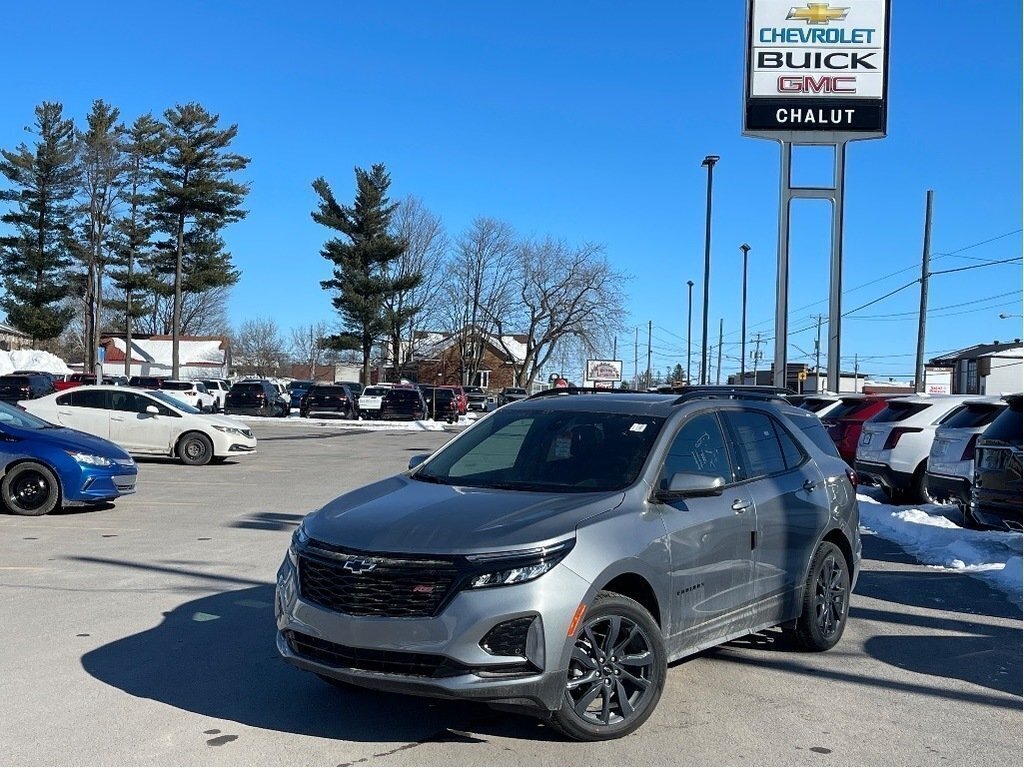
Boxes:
[743,0,889,143]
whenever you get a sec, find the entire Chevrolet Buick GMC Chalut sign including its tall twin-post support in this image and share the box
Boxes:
[743,0,889,392]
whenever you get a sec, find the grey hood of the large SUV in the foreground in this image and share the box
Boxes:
[304,475,624,554]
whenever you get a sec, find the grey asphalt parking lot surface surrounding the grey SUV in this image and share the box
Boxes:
[0,423,1024,766]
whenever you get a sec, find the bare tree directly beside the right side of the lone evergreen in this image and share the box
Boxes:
[384,197,449,368]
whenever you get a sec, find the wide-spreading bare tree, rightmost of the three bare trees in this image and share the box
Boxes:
[483,238,628,387]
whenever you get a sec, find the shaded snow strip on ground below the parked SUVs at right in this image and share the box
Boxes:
[857,487,1024,606]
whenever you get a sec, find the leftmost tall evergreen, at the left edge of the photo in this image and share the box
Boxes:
[0,101,78,344]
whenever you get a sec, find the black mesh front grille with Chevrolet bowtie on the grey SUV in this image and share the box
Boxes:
[299,542,459,617]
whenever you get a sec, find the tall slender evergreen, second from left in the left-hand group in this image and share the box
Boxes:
[76,99,128,371]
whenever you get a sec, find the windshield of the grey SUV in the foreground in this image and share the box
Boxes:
[413,410,665,493]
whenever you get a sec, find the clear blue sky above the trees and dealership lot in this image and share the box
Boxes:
[0,0,1022,378]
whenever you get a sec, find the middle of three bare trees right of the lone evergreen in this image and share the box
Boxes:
[442,217,517,385]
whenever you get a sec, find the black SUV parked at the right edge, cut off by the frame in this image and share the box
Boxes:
[971,392,1024,530]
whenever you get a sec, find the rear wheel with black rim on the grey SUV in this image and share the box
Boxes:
[787,542,850,651]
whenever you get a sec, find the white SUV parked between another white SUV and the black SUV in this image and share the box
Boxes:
[927,397,1007,511]
